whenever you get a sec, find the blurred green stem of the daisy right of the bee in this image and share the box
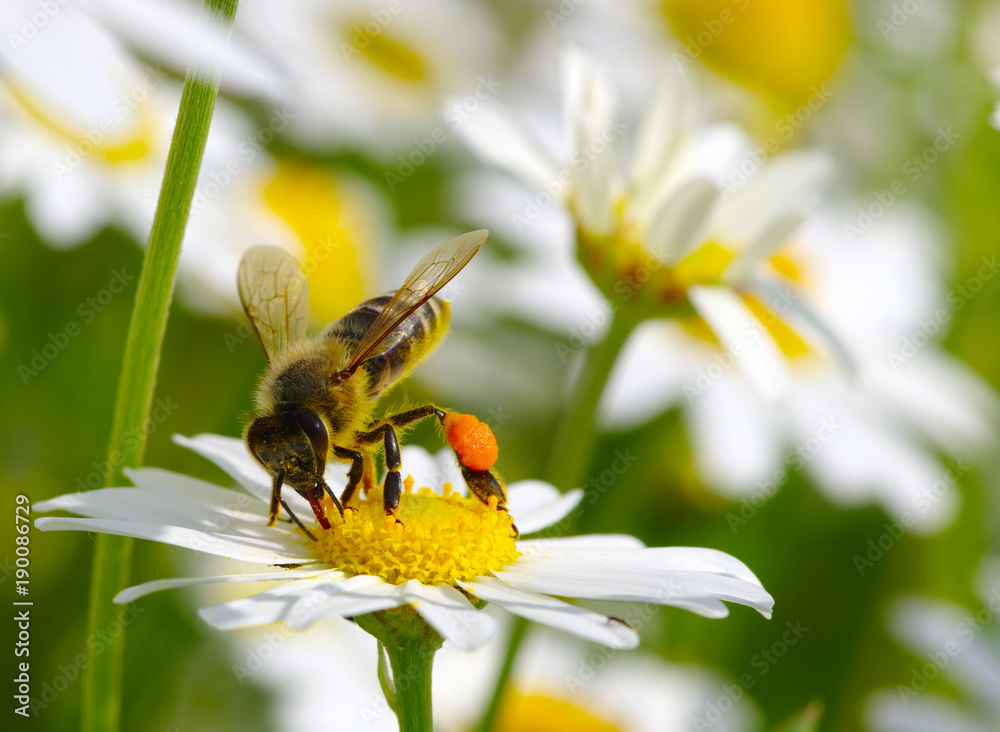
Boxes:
[478,312,638,732]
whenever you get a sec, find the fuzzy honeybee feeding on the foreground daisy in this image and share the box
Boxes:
[237,230,507,535]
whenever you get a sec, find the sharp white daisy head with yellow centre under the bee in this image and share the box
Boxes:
[36,435,773,649]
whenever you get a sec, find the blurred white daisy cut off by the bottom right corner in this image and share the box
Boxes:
[865,558,1000,732]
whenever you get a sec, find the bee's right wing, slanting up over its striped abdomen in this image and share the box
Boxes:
[344,229,489,373]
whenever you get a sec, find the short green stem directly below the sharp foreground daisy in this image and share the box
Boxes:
[354,607,444,732]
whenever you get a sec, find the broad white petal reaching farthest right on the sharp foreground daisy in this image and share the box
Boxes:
[496,541,774,617]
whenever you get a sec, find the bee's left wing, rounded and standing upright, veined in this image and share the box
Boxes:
[236,246,309,363]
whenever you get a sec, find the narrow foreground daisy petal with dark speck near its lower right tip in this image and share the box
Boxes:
[458,577,639,649]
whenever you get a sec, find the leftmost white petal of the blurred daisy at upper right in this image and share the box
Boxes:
[457,103,558,190]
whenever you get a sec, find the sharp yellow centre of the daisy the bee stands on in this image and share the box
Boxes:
[316,478,519,585]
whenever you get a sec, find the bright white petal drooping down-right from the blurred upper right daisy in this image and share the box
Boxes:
[688,285,791,402]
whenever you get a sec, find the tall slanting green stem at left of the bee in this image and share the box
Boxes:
[81,0,237,732]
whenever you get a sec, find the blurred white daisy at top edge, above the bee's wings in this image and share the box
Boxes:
[236,0,499,159]
